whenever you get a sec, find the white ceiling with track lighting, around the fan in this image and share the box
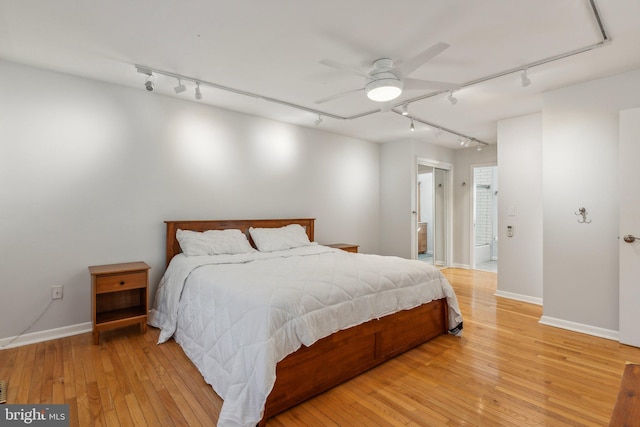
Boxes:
[0,0,640,148]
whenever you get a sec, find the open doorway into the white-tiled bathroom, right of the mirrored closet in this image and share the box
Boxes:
[471,166,498,272]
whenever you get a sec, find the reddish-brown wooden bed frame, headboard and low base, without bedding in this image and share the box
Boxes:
[165,218,448,426]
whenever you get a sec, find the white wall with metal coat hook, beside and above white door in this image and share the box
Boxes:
[542,70,640,335]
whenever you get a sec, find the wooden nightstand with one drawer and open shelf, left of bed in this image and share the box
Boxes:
[89,262,151,344]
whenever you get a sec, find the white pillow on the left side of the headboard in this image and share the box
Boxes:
[176,229,255,256]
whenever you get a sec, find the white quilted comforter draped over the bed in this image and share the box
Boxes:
[149,245,462,426]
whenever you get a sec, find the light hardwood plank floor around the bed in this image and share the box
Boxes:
[0,269,640,427]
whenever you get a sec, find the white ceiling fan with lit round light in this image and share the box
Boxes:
[316,43,460,104]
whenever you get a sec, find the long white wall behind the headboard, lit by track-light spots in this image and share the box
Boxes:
[0,61,380,339]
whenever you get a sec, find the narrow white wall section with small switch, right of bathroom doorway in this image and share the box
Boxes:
[497,113,543,304]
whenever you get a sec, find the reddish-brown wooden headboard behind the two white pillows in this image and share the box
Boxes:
[164,218,316,265]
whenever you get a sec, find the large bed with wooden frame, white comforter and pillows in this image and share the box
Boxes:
[149,218,462,426]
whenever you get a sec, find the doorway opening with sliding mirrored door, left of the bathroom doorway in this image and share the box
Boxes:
[414,159,451,267]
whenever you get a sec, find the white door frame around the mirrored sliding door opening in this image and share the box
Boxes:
[410,156,453,268]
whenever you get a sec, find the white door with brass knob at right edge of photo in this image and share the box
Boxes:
[619,108,640,347]
